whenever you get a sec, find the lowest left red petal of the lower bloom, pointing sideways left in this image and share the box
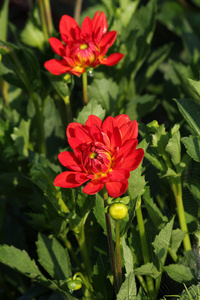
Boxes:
[54,171,89,188]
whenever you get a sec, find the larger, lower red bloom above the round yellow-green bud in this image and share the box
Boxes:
[54,114,144,198]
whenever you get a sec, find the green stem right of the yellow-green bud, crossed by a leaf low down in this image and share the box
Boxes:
[135,197,155,299]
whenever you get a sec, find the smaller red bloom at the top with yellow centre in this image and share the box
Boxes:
[44,11,124,76]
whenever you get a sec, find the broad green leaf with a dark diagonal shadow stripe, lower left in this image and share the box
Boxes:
[36,233,71,280]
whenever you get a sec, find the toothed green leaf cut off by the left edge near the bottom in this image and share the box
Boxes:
[0,245,47,281]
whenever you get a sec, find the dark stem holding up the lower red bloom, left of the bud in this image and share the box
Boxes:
[103,186,119,295]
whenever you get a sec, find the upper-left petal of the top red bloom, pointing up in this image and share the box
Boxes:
[59,15,80,43]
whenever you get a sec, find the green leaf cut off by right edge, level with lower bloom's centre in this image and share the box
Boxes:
[181,135,200,162]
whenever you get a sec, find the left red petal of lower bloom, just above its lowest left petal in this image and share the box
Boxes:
[58,151,83,172]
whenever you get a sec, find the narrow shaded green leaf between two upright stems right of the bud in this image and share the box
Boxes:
[143,187,168,228]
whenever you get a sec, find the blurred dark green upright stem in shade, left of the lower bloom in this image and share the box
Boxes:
[31,93,46,155]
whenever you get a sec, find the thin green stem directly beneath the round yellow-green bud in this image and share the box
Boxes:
[115,220,122,289]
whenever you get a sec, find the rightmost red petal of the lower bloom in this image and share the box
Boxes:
[123,148,144,171]
